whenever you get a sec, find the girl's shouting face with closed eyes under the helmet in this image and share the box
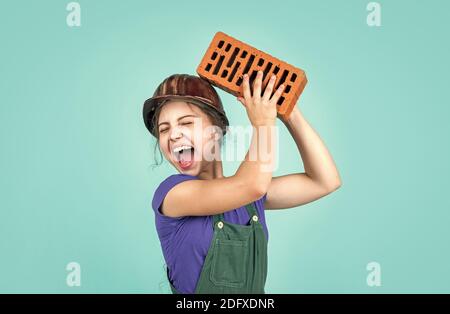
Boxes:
[158,100,220,176]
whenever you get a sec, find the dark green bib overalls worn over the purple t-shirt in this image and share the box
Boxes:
[167,203,267,294]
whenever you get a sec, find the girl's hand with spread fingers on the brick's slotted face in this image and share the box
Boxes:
[237,71,284,127]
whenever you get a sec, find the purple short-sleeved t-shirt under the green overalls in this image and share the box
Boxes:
[152,174,269,294]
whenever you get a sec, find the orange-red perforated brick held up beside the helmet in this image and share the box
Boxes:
[197,32,307,119]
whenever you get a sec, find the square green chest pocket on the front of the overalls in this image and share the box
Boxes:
[210,239,249,288]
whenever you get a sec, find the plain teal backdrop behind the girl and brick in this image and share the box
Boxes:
[0,0,450,293]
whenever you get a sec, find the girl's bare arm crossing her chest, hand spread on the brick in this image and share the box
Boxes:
[162,72,283,217]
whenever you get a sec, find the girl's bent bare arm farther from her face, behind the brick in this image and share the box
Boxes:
[264,107,341,209]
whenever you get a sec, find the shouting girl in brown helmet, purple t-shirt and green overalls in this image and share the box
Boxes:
[143,71,341,294]
